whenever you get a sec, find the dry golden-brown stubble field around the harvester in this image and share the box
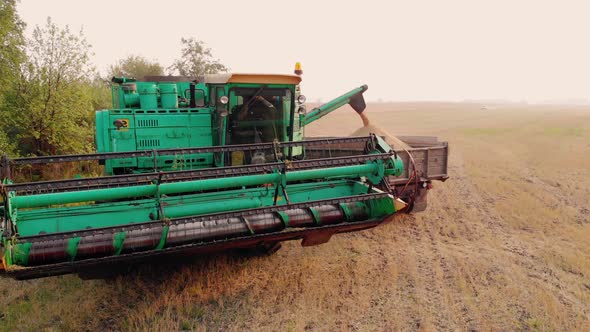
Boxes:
[0,103,590,331]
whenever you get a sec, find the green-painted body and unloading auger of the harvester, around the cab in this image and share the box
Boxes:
[95,78,366,175]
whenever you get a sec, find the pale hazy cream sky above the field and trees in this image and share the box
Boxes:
[19,0,590,101]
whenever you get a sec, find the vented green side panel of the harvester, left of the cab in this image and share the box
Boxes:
[96,109,214,175]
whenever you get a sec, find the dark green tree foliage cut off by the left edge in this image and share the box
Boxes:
[0,0,25,155]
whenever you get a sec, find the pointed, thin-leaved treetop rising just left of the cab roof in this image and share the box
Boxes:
[168,37,228,77]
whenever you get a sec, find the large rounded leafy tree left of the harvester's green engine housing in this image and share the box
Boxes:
[10,19,95,155]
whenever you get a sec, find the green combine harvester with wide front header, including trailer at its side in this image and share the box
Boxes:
[0,66,447,279]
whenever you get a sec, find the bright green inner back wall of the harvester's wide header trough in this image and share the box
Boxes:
[17,180,358,236]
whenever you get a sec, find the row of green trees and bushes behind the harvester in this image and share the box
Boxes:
[0,9,227,161]
